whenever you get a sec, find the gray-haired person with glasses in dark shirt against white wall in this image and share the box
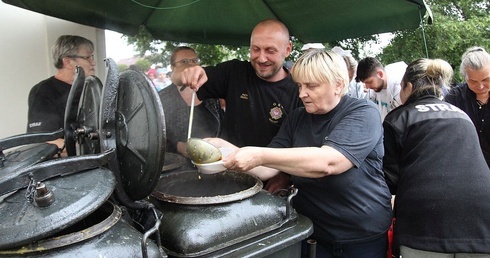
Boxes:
[27,35,95,151]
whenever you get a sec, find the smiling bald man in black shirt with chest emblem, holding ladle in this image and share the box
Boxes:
[180,20,302,191]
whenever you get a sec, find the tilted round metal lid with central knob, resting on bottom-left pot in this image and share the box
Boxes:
[0,165,115,249]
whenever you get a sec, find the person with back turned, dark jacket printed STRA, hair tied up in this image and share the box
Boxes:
[383,59,490,258]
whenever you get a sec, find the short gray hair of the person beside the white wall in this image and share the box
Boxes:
[52,35,94,69]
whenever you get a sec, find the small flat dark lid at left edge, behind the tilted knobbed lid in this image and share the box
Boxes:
[0,143,58,175]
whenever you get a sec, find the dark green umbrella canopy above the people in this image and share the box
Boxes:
[2,0,430,46]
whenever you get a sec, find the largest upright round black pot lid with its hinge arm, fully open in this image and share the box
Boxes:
[100,59,166,201]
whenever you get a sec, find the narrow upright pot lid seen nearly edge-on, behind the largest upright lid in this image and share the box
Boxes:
[65,66,103,156]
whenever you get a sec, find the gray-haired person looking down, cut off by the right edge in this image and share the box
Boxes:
[445,47,490,167]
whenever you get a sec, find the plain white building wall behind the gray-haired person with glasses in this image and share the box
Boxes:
[0,1,106,139]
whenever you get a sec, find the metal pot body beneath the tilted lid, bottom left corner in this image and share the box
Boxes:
[0,202,162,258]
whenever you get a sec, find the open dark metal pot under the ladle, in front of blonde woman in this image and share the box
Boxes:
[151,170,312,257]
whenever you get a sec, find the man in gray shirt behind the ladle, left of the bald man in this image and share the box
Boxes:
[158,46,223,166]
